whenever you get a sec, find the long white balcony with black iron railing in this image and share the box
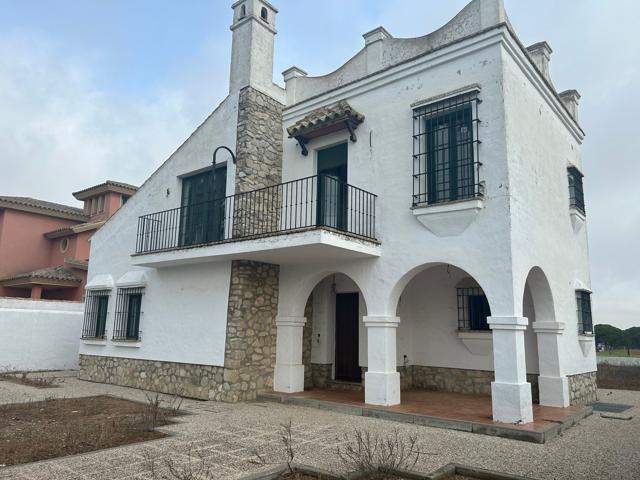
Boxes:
[133,175,379,267]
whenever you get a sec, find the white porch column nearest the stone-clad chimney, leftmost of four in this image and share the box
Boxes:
[273,317,307,393]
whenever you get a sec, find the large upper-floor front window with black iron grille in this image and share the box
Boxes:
[413,92,482,206]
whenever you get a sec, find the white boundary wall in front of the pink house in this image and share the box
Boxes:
[0,298,84,372]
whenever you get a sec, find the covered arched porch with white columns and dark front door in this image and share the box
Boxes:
[274,263,575,430]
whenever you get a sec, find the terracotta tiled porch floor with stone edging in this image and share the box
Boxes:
[268,390,591,443]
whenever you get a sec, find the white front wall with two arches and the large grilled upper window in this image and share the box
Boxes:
[280,29,513,326]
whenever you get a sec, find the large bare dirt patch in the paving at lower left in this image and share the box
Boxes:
[0,396,175,466]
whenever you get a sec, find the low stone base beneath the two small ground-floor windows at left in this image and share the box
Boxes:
[78,355,225,400]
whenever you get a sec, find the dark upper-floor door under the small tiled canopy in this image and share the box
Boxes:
[316,143,348,230]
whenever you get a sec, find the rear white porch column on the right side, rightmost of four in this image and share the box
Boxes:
[532,322,569,407]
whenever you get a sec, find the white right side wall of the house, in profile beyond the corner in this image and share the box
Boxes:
[503,43,596,375]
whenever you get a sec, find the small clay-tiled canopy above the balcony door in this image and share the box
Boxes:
[287,100,364,155]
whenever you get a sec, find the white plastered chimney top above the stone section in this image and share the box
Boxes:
[229,0,278,93]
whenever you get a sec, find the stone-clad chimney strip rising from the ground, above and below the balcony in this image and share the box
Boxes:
[213,87,283,402]
